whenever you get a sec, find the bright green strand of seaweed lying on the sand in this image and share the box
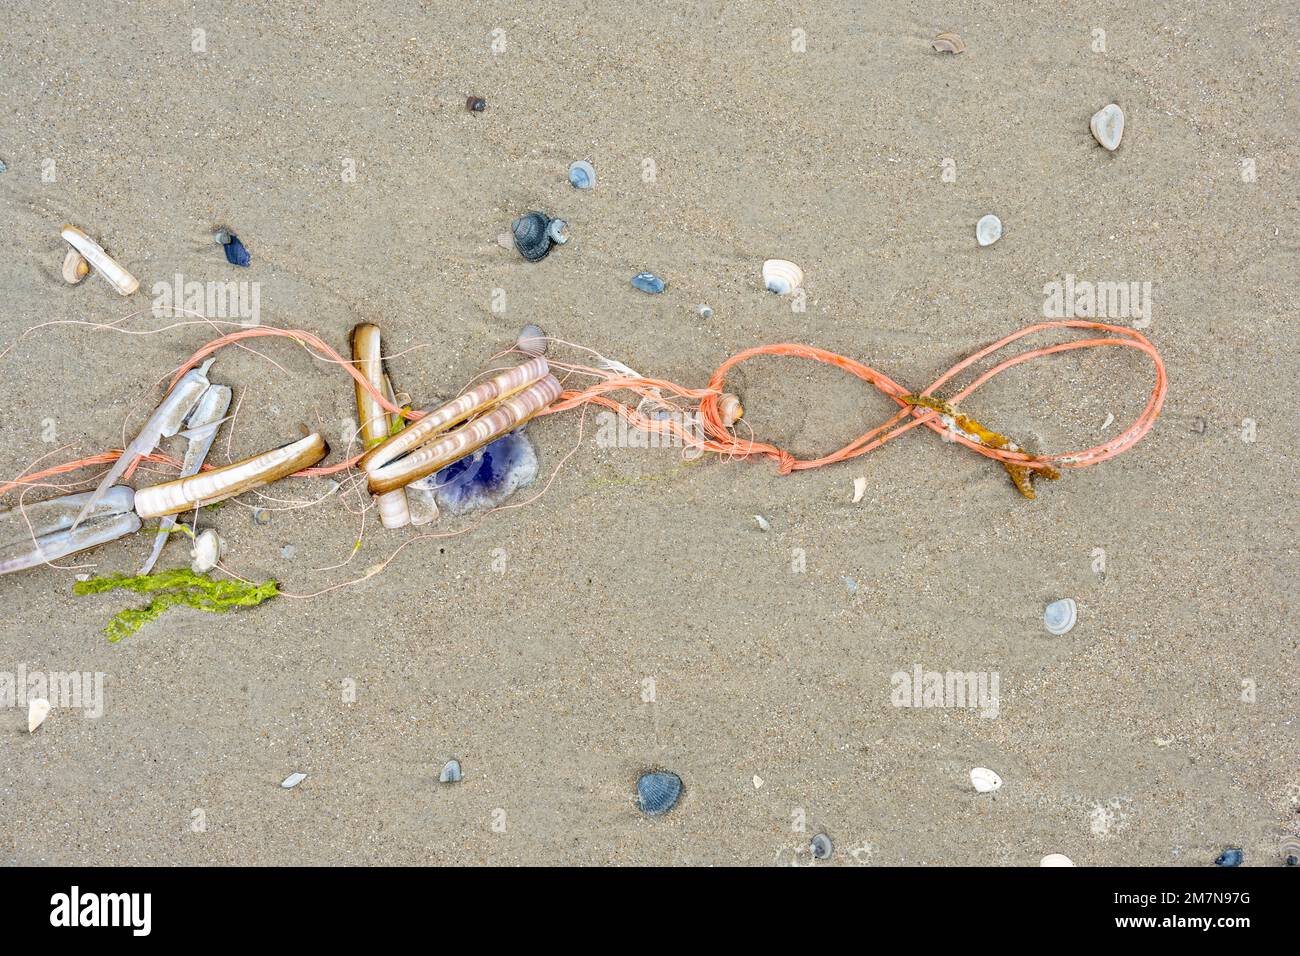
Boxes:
[73,567,280,644]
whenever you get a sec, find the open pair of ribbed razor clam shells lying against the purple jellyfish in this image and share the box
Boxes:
[359,358,562,494]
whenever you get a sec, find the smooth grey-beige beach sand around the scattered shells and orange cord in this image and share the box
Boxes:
[0,0,1300,866]
